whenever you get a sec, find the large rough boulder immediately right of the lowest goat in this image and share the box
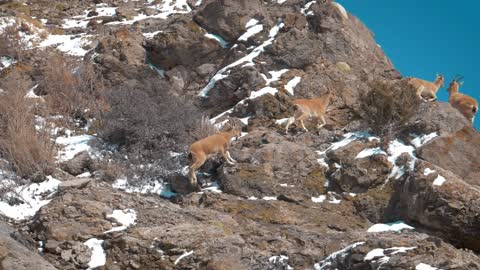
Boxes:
[221,132,325,198]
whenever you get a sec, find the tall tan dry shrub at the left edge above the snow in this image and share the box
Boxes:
[0,76,55,181]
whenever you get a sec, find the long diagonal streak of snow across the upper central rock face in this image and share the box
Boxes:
[198,23,284,97]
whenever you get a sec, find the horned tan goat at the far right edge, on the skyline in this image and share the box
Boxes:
[447,75,478,124]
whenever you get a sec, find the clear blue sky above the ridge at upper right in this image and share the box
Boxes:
[337,0,480,129]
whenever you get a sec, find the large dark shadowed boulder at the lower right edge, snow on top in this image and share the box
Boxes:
[390,160,480,250]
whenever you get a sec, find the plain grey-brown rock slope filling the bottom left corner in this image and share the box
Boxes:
[0,222,57,270]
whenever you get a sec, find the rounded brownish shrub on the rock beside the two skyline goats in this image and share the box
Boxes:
[362,80,421,141]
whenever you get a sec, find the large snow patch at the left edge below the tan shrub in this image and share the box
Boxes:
[0,176,60,220]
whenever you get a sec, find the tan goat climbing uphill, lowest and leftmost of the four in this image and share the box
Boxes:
[188,122,241,189]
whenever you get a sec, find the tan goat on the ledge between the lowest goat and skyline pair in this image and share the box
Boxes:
[285,93,332,133]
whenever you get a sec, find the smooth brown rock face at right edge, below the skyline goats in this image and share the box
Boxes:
[418,126,480,186]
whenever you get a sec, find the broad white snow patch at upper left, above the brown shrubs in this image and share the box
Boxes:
[38,34,90,56]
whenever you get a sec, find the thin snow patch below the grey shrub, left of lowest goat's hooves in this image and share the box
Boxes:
[112,178,177,198]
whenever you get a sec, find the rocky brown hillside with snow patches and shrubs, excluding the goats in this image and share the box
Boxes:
[0,0,480,270]
